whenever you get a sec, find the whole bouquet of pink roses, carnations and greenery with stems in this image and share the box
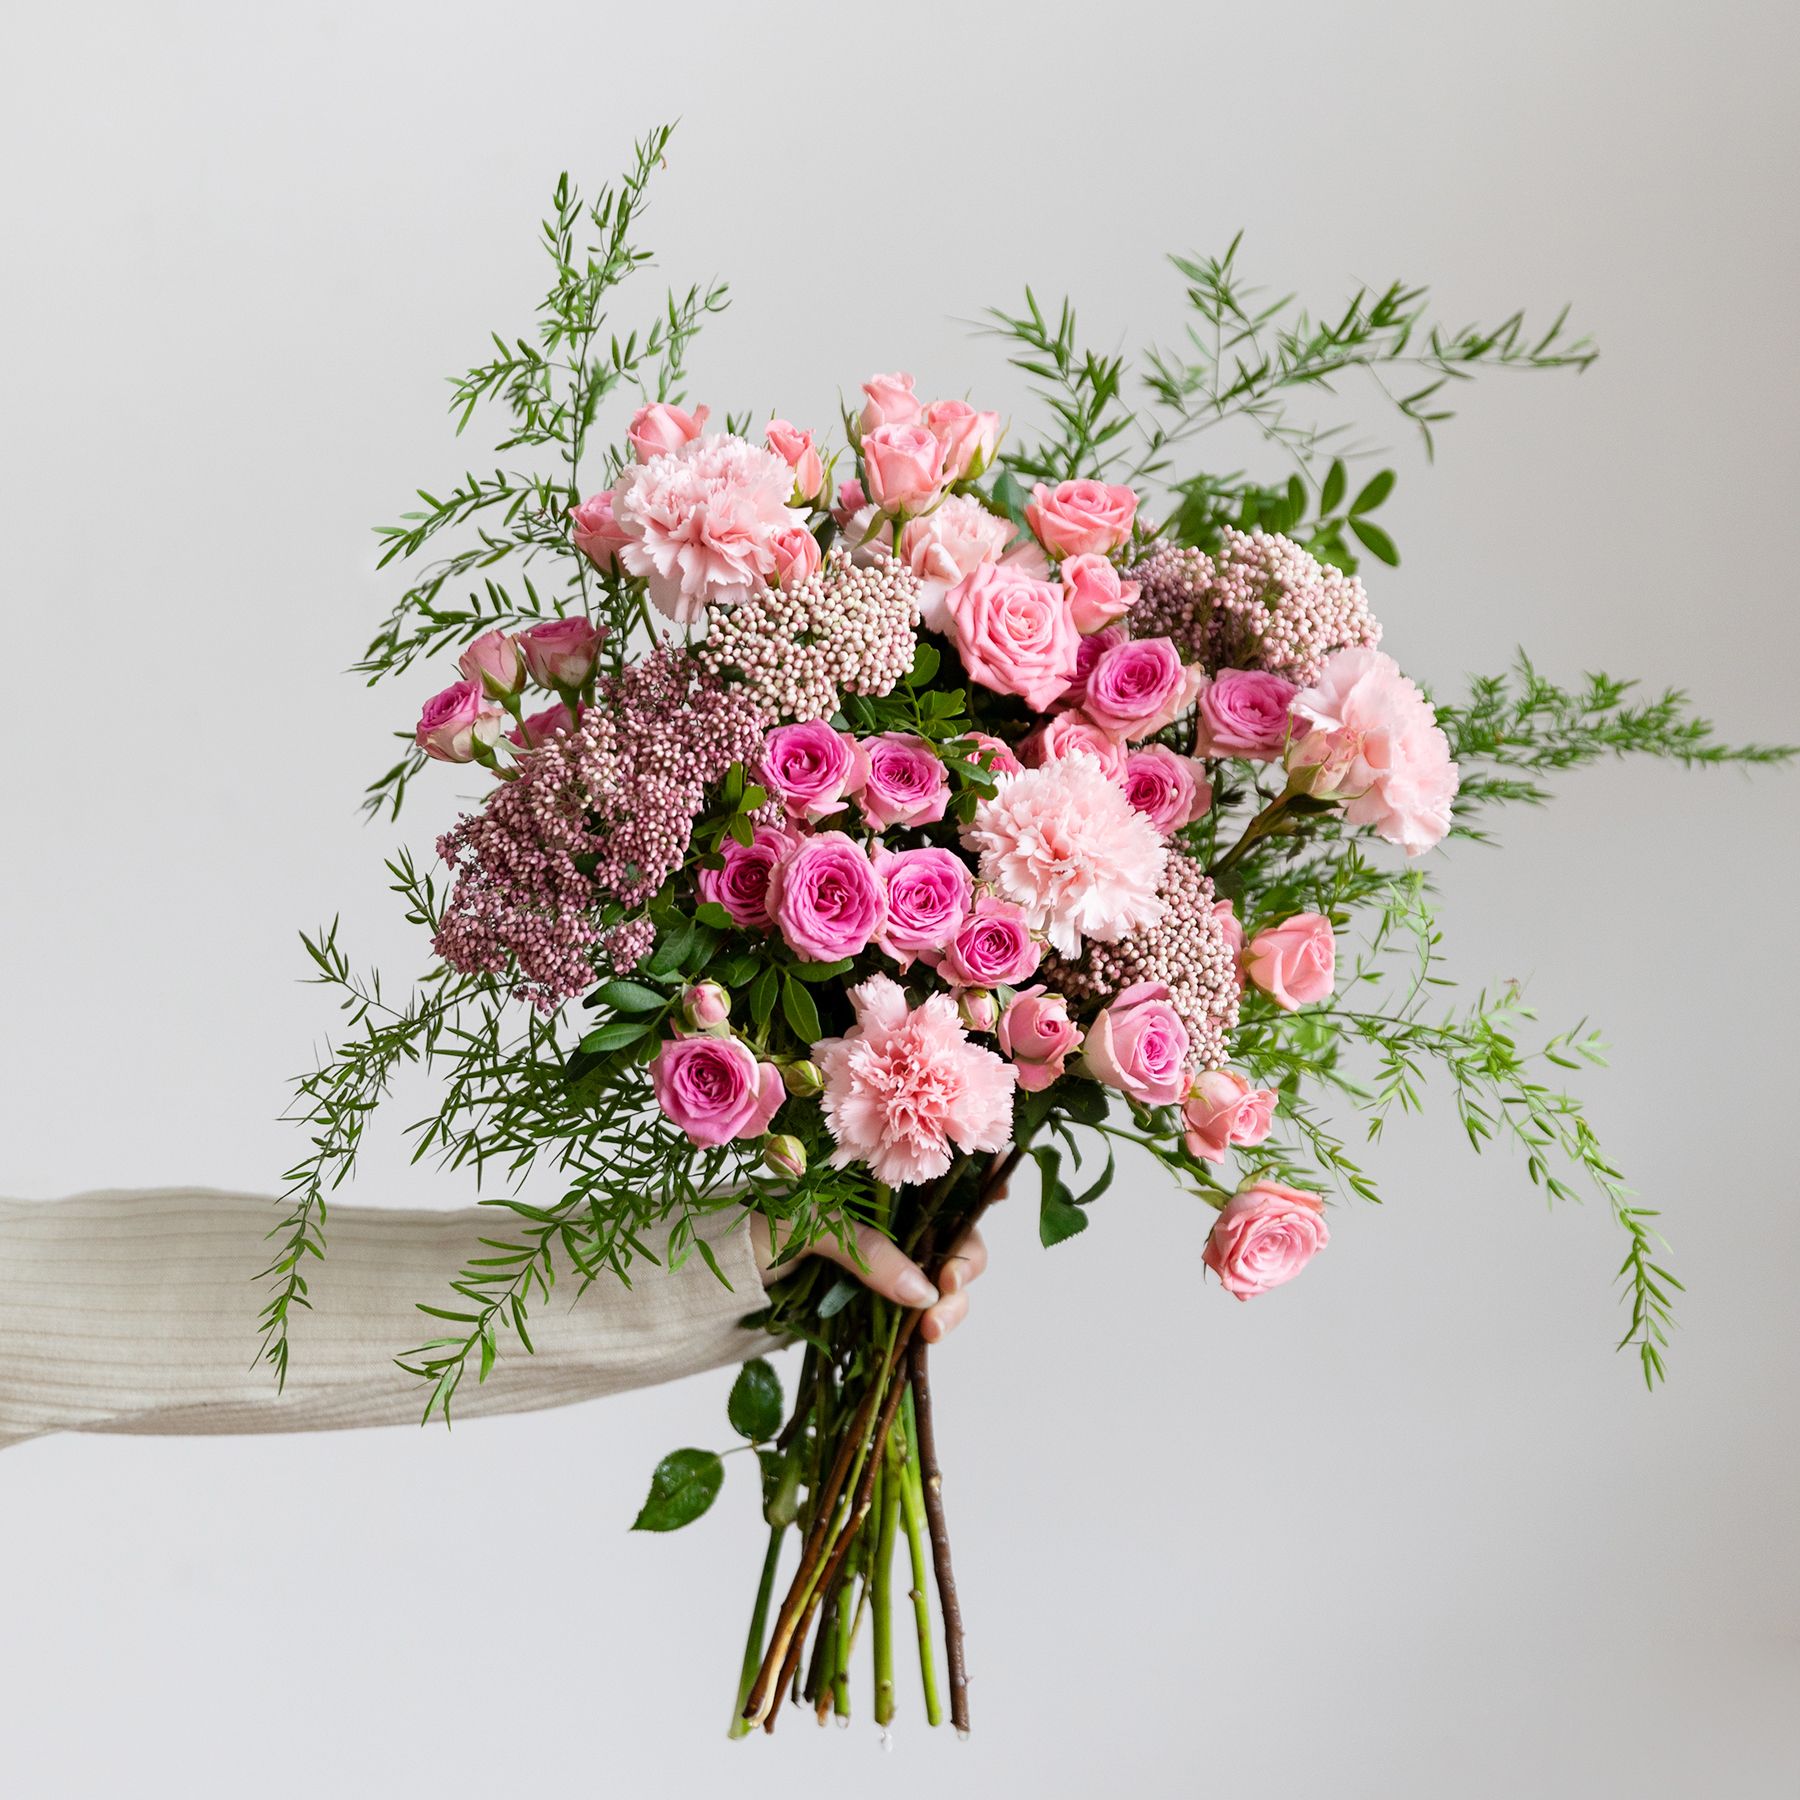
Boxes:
[263,131,1786,1732]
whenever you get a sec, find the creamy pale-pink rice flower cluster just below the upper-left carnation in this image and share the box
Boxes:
[695,551,920,725]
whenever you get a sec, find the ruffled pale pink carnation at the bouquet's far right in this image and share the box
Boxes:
[1287,650,1460,857]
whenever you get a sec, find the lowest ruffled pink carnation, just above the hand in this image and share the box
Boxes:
[814,976,1013,1188]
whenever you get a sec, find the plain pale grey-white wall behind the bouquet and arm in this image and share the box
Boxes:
[0,0,1800,1800]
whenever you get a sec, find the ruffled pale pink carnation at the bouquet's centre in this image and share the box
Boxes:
[963,756,1168,956]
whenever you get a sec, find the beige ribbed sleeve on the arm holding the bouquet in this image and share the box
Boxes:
[0,1188,769,1447]
